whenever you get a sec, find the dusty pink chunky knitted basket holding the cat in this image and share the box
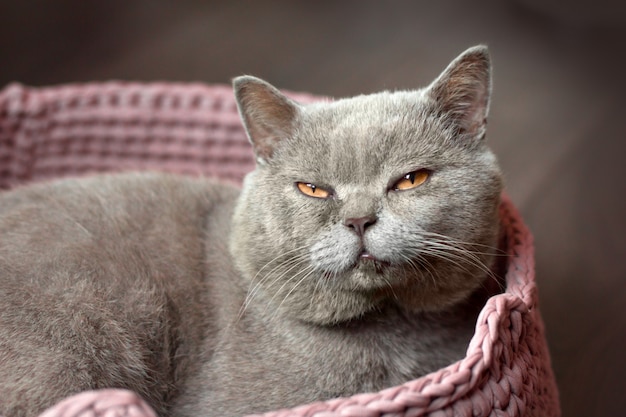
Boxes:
[0,83,560,417]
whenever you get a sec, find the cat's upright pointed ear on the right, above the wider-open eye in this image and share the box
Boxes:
[427,45,491,139]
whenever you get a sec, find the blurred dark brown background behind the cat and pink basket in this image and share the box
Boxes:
[0,0,626,417]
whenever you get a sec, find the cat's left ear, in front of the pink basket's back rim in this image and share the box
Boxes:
[233,75,300,163]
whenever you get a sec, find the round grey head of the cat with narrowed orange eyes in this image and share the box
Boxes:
[231,46,502,324]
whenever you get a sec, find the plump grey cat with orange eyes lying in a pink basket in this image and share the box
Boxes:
[0,46,502,417]
